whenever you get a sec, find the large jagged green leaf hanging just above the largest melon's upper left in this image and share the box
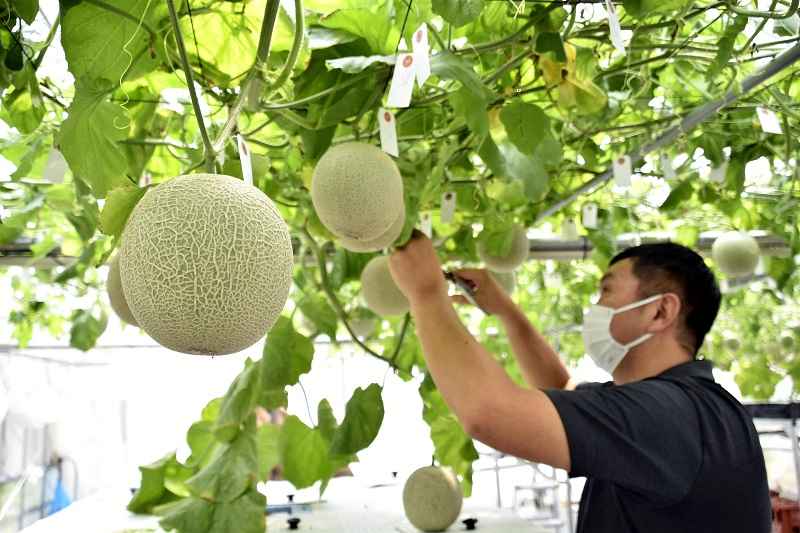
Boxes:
[58,82,130,198]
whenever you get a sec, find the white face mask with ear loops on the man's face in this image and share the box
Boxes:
[583,294,663,374]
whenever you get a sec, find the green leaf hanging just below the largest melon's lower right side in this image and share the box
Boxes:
[261,316,314,389]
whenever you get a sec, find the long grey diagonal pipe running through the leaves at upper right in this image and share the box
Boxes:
[534,44,800,223]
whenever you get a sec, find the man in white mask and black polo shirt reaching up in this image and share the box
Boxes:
[390,232,770,533]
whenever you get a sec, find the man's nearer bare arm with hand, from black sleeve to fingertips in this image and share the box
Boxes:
[391,237,570,470]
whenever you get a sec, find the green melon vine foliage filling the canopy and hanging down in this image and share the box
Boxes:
[0,0,800,532]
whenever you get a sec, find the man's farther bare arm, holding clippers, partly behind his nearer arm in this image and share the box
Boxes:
[454,269,575,390]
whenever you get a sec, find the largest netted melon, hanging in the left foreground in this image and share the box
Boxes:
[120,174,292,355]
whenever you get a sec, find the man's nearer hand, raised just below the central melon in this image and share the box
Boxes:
[389,230,447,303]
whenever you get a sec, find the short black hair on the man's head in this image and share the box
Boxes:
[610,242,722,358]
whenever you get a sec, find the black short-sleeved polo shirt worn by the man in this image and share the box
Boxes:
[544,361,771,533]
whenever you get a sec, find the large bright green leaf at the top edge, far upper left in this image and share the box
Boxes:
[61,0,161,84]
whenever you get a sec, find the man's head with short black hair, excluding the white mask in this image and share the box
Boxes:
[598,243,721,357]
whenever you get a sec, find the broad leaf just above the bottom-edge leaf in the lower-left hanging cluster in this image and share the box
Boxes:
[186,419,259,502]
